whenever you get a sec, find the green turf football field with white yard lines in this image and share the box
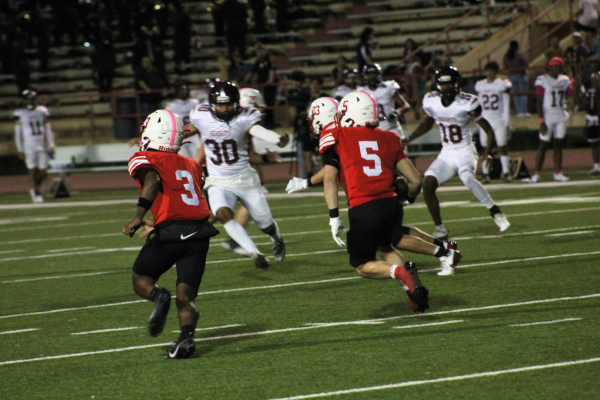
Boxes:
[0,171,600,400]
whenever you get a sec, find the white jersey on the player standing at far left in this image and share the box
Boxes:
[13,106,54,151]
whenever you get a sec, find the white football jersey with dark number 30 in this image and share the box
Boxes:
[190,104,261,178]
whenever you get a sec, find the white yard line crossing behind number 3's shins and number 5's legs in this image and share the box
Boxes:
[0,250,600,319]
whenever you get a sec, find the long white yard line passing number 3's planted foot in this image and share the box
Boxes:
[0,293,600,365]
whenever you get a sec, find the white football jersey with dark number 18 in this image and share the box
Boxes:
[423,92,481,149]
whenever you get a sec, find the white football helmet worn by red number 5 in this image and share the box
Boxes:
[337,92,379,128]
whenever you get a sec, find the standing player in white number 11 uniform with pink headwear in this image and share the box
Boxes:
[531,57,573,183]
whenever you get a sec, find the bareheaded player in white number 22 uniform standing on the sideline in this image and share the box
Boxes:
[475,61,512,183]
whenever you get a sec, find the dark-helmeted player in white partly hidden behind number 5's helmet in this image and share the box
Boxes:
[357,64,410,138]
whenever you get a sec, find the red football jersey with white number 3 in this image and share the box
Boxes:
[129,151,210,224]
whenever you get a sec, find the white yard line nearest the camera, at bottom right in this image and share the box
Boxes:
[271,357,600,400]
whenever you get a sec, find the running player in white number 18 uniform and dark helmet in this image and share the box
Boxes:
[405,67,510,240]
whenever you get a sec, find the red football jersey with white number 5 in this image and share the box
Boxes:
[319,126,406,208]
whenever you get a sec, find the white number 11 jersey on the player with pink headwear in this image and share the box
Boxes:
[535,74,572,122]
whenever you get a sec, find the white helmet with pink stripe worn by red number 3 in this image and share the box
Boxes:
[140,110,184,153]
